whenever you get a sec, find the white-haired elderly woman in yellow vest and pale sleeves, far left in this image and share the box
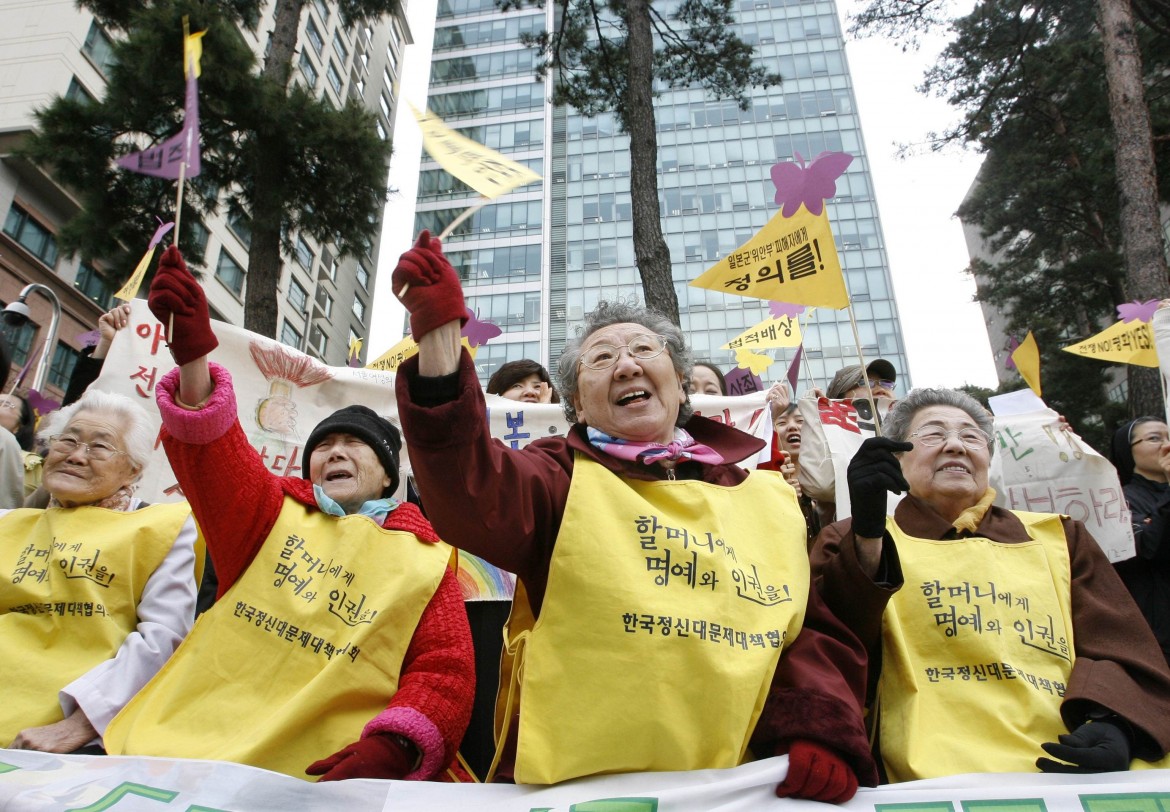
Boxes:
[0,390,195,752]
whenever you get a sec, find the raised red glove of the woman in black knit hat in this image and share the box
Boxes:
[146,246,219,366]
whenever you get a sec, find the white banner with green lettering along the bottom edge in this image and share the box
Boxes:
[0,750,1170,812]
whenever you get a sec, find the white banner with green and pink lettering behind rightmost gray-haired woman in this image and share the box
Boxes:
[990,408,1135,562]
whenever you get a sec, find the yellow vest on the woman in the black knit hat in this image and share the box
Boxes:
[105,496,450,779]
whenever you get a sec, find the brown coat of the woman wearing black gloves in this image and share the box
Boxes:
[812,496,1170,761]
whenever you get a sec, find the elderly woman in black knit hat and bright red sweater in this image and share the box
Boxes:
[106,247,475,780]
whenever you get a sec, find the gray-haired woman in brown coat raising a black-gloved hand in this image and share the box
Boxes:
[813,390,1170,782]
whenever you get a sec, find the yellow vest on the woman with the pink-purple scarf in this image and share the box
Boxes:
[509,454,808,784]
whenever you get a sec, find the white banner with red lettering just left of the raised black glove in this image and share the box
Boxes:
[797,398,902,519]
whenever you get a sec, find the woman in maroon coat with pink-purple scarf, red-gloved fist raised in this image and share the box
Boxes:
[393,233,876,801]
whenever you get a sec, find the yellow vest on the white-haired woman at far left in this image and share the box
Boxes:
[0,502,194,746]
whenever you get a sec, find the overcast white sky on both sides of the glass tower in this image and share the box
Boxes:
[366,0,996,395]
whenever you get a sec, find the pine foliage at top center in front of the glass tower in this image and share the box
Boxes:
[500,0,780,126]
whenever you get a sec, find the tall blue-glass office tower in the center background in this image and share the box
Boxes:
[415,0,909,390]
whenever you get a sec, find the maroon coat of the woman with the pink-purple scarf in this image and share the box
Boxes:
[395,352,878,786]
